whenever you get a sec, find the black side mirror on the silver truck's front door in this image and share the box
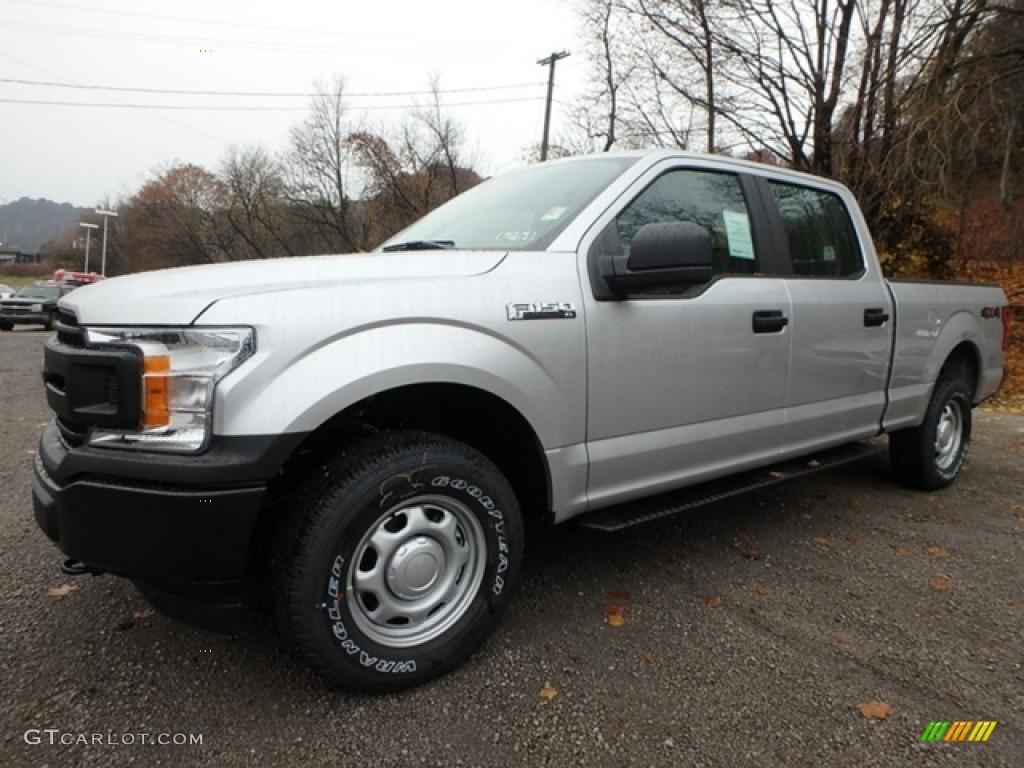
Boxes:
[603,221,714,296]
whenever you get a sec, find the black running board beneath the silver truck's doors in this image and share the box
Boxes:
[580,440,886,532]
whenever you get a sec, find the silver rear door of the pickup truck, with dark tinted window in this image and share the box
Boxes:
[759,179,893,453]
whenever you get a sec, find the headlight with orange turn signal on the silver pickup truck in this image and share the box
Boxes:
[85,328,256,453]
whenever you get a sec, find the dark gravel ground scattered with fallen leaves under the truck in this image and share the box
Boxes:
[0,330,1024,768]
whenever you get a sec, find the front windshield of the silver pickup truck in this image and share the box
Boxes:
[381,156,636,251]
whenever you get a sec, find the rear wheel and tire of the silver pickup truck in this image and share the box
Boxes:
[889,372,974,490]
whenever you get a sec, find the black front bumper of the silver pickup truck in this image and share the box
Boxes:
[33,423,301,632]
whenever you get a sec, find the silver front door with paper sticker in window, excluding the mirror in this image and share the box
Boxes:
[583,164,790,507]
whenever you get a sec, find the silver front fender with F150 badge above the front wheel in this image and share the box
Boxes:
[195,264,587,450]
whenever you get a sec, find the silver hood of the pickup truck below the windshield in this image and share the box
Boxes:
[60,251,506,326]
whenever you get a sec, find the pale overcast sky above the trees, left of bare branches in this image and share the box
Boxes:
[0,0,585,206]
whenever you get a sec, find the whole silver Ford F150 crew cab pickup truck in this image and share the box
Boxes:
[34,151,1010,691]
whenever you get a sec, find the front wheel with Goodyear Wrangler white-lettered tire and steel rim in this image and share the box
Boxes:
[273,432,523,692]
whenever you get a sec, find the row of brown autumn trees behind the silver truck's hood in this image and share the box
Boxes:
[110,72,480,273]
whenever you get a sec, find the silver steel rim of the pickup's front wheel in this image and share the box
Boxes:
[346,496,486,647]
